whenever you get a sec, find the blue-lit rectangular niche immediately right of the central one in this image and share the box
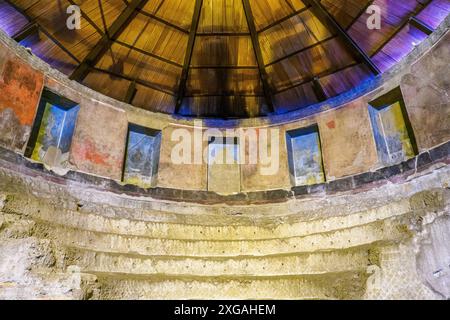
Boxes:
[286,125,325,186]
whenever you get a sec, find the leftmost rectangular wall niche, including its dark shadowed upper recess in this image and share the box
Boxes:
[25,89,80,168]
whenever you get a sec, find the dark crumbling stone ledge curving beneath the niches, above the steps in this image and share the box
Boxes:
[0,142,450,204]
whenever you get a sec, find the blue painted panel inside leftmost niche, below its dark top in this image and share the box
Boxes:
[31,103,79,167]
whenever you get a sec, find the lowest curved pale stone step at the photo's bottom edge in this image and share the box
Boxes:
[95,272,367,300]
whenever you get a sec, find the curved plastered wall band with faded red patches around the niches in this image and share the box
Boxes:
[0,19,450,198]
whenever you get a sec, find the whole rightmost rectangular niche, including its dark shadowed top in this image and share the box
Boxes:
[369,88,418,166]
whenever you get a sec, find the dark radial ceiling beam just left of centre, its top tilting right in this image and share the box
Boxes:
[175,0,203,113]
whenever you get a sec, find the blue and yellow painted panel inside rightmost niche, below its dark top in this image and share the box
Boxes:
[369,102,415,165]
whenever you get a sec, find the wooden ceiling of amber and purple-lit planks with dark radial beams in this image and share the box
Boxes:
[0,0,450,118]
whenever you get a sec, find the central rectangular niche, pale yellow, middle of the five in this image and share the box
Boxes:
[208,137,241,194]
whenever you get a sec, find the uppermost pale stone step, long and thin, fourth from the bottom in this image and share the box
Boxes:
[26,201,410,240]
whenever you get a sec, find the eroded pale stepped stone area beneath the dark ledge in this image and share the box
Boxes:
[0,160,450,299]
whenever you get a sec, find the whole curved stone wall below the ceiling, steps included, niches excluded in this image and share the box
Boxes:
[0,15,450,299]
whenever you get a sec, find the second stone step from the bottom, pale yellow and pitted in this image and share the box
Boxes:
[65,247,371,277]
